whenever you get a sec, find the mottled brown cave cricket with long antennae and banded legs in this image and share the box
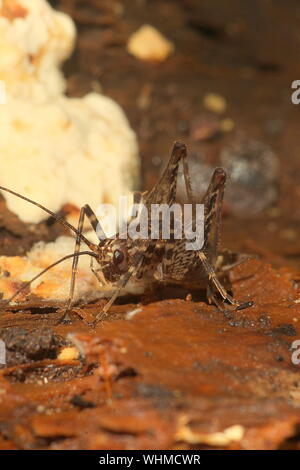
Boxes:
[0,142,252,325]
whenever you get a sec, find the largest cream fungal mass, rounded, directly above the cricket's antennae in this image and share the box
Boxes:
[0,93,138,223]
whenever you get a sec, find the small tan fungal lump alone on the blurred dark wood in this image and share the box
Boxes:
[127,24,174,62]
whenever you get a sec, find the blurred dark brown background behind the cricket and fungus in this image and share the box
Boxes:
[51,0,300,265]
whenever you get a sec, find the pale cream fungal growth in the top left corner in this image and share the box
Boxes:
[0,0,76,100]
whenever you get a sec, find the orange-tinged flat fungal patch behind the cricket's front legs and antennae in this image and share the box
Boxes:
[0,236,144,303]
